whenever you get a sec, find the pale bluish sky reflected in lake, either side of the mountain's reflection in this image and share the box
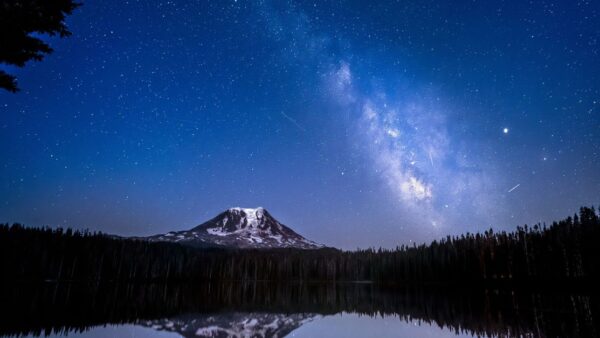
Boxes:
[28,313,474,338]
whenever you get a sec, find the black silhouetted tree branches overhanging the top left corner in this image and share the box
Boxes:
[0,0,80,92]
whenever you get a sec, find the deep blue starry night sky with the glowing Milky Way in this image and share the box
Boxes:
[0,0,600,249]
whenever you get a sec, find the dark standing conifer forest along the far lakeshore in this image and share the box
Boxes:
[0,207,600,284]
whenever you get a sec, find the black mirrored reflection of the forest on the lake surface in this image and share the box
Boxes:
[0,283,598,337]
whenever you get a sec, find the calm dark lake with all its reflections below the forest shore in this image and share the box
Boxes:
[0,283,598,337]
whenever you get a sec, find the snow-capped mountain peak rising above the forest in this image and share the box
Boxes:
[147,207,323,249]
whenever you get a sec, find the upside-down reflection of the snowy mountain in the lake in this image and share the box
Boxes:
[136,312,320,338]
